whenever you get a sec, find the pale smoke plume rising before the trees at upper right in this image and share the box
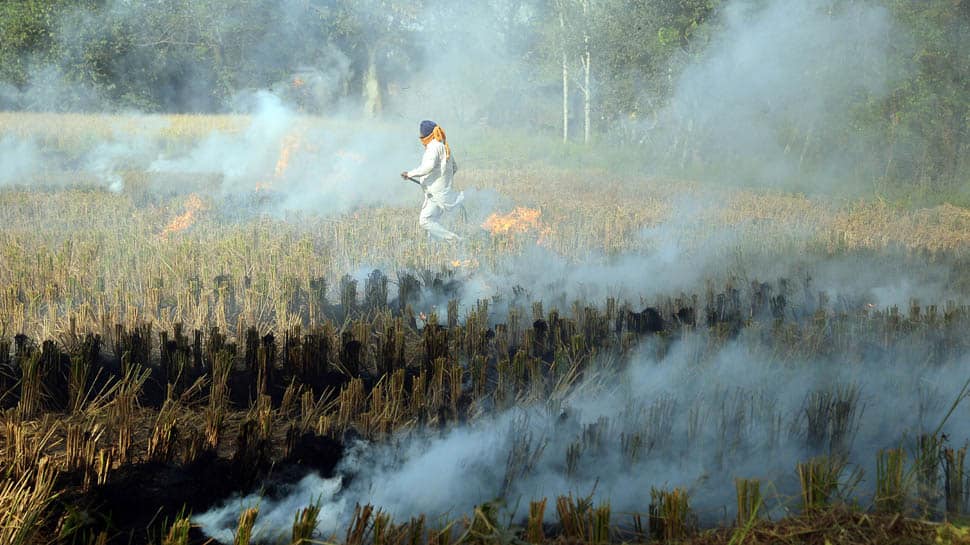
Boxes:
[639,0,911,194]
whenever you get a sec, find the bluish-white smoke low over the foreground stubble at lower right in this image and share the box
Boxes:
[196,331,970,540]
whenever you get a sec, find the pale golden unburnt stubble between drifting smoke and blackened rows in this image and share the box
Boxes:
[0,171,970,339]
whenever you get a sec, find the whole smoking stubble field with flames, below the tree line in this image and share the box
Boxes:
[0,113,970,545]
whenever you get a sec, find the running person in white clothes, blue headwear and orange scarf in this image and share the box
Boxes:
[401,120,465,240]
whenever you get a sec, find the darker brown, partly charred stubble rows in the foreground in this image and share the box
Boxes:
[0,276,970,543]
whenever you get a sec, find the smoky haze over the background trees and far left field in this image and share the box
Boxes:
[0,0,968,195]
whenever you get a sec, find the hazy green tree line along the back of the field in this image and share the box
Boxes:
[0,0,970,185]
